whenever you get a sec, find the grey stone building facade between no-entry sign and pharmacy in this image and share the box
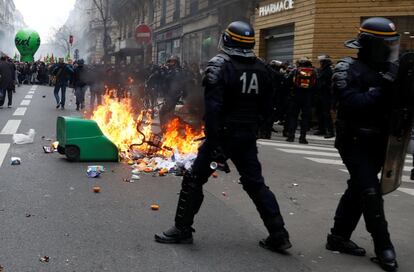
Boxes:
[153,0,256,63]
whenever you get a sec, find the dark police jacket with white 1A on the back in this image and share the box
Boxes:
[203,53,273,140]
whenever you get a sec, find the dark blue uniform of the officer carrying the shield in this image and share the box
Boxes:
[332,58,392,250]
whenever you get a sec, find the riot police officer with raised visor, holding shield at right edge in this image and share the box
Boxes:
[326,17,400,271]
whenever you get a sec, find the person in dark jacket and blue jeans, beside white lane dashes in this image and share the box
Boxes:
[52,58,74,110]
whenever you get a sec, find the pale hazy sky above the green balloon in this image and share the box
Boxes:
[14,0,76,43]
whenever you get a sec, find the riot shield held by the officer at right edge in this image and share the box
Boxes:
[381,53,414,195]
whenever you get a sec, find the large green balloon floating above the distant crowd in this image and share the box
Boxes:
[14,29,40,62]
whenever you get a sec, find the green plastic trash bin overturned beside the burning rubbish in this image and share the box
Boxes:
[56,116,119,162]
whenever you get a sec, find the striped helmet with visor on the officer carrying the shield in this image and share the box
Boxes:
[345,17,400,62]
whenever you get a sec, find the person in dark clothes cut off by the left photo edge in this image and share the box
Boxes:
[0,56,15,108]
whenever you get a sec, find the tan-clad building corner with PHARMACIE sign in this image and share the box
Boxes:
[254,0,414,63]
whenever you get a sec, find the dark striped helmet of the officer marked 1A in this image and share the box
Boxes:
[220,21,256,57]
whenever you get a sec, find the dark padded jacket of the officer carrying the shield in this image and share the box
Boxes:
[332,58,390,136]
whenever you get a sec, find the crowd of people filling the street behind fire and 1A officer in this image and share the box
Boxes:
[0,50,335,144]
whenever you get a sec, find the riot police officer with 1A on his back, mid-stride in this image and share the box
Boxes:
[155,21,292,252]
